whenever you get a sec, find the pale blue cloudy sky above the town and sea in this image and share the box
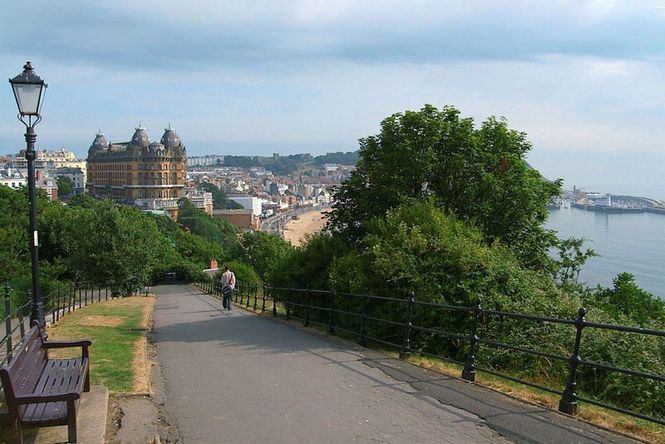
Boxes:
[0,0,665,200]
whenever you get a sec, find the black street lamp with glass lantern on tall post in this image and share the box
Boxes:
[9,62,47,326]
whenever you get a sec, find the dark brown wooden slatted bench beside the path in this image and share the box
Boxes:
[0,322,92,442]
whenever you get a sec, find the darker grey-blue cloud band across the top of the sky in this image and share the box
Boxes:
[0,0,665,71]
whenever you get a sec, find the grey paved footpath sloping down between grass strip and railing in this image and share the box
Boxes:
[154,285,634,444]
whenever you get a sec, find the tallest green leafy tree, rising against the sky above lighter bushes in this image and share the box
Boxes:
[330,105,561,267]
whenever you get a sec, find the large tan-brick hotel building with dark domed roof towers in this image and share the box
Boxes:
[86,125,187,217]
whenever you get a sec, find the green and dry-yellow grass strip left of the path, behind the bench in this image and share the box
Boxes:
[48,297,154,392]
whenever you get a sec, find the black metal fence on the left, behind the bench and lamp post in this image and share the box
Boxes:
[0,282,149,365]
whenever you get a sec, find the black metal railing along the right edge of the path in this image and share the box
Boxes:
[199,280,665,425]
